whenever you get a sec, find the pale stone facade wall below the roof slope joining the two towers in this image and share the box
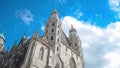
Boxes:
[49,43,83,68]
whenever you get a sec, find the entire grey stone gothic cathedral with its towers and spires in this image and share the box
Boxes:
[0,10,85,68]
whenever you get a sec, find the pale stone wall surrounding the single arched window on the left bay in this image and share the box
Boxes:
[31,41,48,68]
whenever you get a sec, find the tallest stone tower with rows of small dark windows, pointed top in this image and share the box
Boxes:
[44,9,61,50]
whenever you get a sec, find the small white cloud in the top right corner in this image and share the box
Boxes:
[108,0,120,18]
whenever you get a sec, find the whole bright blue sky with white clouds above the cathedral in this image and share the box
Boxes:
[0,0,120,68]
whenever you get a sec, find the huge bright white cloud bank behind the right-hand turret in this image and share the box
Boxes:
[62,16,120,68]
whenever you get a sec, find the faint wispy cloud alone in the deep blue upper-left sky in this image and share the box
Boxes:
[16,9,34,25]
